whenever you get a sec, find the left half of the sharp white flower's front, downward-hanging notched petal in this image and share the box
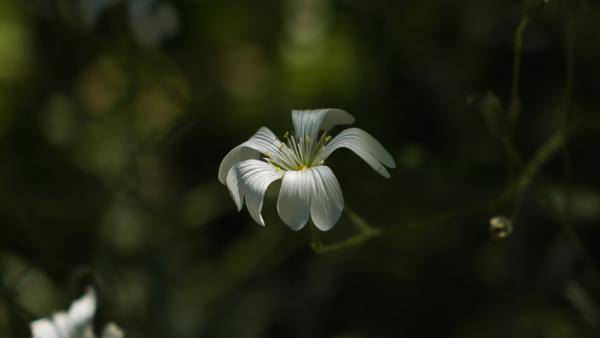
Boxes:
[277,170,314,231]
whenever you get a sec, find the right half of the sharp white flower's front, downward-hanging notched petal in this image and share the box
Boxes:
[307,166,344,231]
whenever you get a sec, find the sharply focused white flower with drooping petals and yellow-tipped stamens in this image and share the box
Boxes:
[219,109,396,231]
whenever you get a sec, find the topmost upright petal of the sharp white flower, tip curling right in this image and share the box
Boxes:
[292,108,355,140]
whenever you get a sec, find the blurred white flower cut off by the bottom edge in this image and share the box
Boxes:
[31,288,124,338]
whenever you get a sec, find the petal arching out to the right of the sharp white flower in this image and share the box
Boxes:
[319,128,396,178]
